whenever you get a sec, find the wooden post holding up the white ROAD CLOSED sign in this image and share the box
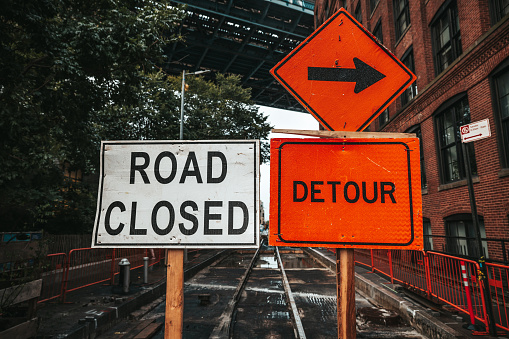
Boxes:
[164,249,184,339]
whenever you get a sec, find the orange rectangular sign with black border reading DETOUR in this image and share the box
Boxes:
[269,138,423,250]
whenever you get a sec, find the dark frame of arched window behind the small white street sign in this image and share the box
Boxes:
[433,93,477,184]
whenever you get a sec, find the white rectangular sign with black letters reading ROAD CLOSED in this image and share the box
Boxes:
[92,140,260,248]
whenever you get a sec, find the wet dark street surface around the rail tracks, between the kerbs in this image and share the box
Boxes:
[99,251,427,339]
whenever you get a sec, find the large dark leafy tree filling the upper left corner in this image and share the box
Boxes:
[0,0,184,230]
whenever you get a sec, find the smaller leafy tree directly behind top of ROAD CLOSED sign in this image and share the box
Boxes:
[94,72,272,161]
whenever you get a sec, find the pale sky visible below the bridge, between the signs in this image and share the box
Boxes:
[259,106,319,220]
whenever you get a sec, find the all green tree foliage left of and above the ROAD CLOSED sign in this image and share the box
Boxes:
[0,0,271,233]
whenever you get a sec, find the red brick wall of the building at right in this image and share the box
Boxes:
[330,0,509,259]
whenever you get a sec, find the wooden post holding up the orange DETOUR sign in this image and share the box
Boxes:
[336,248,357,339]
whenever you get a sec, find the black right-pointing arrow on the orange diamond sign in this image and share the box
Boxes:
[308,58,385,93]
